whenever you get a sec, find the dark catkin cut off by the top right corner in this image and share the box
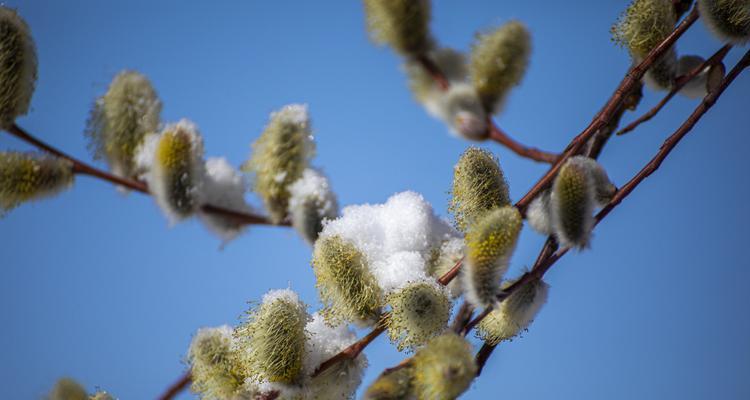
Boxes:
[698,0,750,44]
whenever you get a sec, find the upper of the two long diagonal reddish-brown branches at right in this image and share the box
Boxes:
[516,7,698,215]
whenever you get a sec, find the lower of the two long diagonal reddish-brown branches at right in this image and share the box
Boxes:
[472,50,750,371]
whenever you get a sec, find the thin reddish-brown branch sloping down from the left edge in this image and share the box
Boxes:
[2,124,289,226]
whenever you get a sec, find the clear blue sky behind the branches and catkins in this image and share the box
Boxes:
[0,0,750,399]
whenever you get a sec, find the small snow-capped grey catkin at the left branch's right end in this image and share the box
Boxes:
[289,168,339,244]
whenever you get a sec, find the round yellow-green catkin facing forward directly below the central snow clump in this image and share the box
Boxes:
[386,281,452,351]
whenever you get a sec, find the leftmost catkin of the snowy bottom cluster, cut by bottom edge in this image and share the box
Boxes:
[187,325,244,399]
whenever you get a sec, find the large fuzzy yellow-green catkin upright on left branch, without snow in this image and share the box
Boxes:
[85,70,161,178]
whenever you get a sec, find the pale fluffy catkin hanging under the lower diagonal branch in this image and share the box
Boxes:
[477,279,549,346]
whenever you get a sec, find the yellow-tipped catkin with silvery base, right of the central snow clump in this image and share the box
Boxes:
[461,206,523,307]
